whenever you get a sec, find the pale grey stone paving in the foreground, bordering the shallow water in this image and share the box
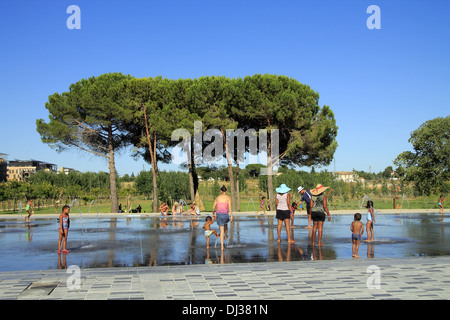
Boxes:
[0,257,450,300]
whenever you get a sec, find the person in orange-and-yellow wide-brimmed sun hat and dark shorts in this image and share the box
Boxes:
[311,184,331,246]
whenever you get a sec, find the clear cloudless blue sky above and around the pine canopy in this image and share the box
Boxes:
[0,0,450,175]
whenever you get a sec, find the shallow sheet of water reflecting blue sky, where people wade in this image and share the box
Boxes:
[0,214,450,271]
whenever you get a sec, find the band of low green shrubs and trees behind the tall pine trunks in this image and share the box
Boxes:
[0,164,440,212]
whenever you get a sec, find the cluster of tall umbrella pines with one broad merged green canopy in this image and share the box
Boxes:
[36,73,337,212]
